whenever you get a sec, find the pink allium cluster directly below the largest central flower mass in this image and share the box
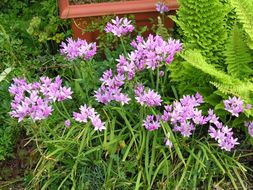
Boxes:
[134,84,162,107]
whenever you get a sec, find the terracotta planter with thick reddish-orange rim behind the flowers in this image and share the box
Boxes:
[58,0,179,41]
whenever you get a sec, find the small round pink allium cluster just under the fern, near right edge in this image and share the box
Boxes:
[224,96,244,117]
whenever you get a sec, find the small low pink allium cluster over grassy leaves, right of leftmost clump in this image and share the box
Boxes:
[73,104,105,131]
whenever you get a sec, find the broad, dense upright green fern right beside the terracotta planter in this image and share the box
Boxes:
[172,0,228,65]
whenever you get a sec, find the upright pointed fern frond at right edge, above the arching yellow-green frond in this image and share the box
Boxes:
[225,25,253,79]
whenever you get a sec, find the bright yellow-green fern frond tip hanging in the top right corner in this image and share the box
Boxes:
[230,0,253,49]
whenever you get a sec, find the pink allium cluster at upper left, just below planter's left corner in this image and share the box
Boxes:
[60,38,97,60]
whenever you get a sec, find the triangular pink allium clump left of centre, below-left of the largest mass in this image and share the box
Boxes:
[95,69,130,105]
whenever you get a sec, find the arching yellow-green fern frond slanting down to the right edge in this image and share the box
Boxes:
[182,50,253,116]
